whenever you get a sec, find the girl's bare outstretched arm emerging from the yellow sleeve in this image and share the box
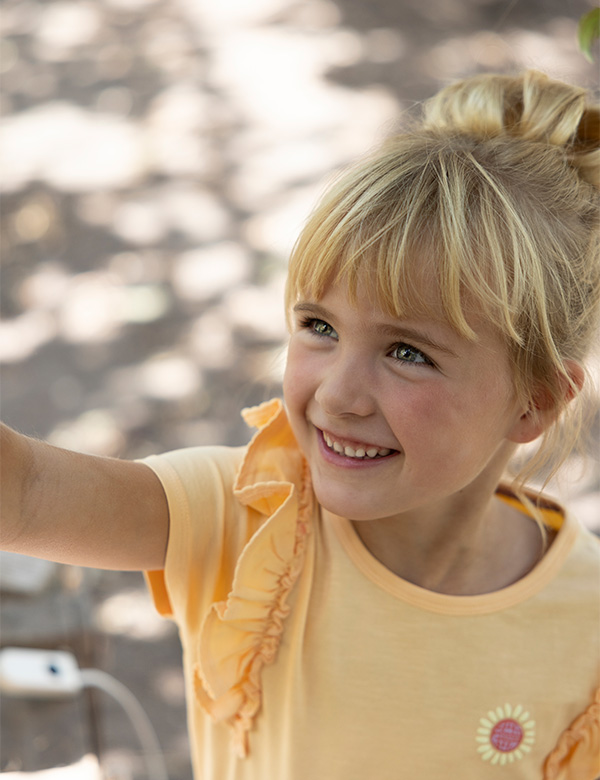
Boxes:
[0,425,169,570]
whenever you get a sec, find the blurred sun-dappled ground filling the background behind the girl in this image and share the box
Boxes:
[0,0,600,780]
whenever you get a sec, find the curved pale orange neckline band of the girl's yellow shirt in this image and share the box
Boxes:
[321,496,577,615]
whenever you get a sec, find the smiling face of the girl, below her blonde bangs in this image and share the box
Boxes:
[284,283,523,520]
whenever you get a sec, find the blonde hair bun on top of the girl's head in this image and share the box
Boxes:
[423,70,600,189]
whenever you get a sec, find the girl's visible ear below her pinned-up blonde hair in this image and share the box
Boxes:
[508,360,585,444]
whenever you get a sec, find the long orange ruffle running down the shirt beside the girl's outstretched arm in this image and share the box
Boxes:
[194,400,313,758]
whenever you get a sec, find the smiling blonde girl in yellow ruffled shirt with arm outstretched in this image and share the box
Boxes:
[3,73,600,780]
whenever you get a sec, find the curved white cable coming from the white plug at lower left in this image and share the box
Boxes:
[81,669,169,780]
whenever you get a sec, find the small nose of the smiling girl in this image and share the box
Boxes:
[315,350,375,417]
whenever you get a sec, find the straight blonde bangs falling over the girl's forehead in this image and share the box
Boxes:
[286,135,535,344]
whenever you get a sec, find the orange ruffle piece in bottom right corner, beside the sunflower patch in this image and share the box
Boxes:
[543,688,600,780]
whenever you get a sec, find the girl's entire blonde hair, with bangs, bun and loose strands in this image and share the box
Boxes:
[286,71,600,502]
